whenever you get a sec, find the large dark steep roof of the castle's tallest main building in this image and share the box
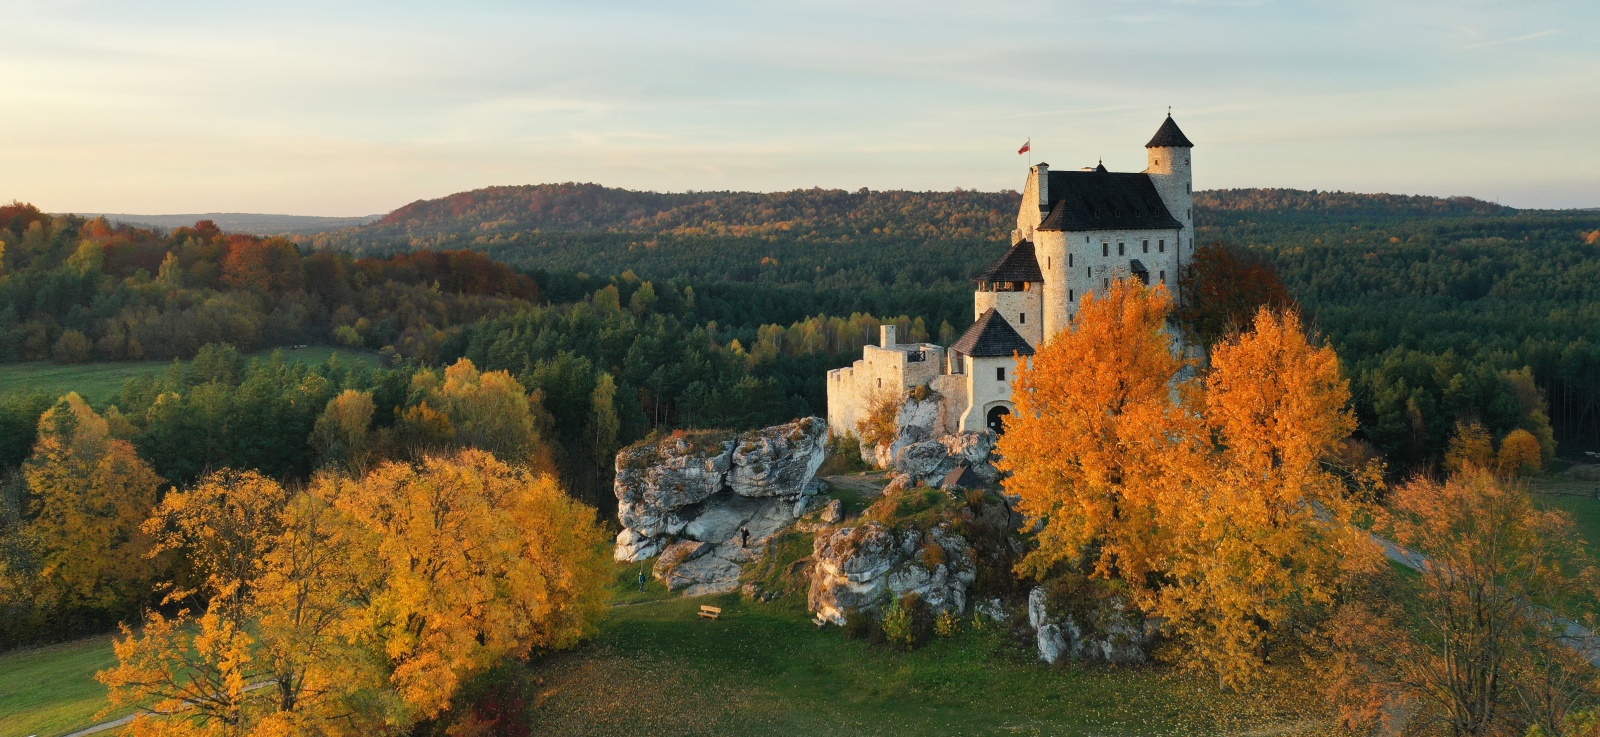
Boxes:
[1038,169,1182,230]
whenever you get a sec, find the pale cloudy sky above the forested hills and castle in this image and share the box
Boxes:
[0,0,1600,216]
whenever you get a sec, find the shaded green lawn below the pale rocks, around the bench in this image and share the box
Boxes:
[528,564,1339,737]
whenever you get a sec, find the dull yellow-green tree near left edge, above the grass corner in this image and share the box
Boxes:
[22,393,165,608]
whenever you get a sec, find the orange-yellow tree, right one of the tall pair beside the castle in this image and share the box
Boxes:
[1150,309,1374,686]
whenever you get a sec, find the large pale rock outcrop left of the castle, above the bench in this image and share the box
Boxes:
[614,417,827,595]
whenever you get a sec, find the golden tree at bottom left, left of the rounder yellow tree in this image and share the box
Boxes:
[98,472,398,737]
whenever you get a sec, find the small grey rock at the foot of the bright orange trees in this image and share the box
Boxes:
[1027,588,1152,665]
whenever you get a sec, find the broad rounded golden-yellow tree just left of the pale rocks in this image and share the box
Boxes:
[312,449,608,716]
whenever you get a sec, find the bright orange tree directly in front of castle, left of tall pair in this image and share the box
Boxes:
[998,280,1197,582]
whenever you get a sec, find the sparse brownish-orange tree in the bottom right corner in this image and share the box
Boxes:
[1328,468,1597,735]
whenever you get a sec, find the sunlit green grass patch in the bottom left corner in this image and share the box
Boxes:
[0,636,120,737]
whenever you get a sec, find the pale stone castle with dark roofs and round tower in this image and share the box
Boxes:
[827,114,1194,435]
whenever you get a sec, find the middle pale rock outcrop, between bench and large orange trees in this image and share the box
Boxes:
[808,521,978,625]
